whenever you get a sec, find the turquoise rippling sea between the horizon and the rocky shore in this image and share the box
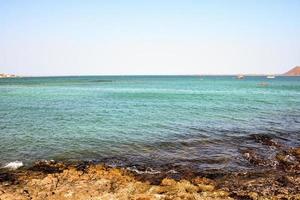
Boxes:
[0,76,300,172]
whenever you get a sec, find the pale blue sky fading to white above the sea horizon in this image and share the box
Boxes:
[0,0,300,76]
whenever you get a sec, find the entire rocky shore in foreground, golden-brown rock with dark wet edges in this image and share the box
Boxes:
[0,145,300,200]
